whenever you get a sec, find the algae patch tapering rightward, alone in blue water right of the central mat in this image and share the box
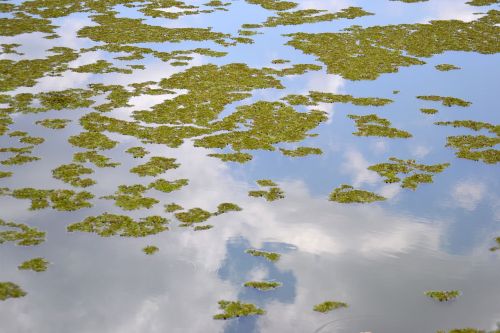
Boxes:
[348,114,412,139]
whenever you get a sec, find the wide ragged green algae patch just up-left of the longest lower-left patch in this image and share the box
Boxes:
[10,187,94,211]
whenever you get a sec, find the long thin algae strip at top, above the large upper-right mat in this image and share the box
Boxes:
[262,7,373,27]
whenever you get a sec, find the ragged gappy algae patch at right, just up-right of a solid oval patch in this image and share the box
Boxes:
[368,157,450,190]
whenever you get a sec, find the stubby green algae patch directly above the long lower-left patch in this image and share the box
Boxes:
[102,184,159,210]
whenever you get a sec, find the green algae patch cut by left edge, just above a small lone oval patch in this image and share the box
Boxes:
[0,219,45,246]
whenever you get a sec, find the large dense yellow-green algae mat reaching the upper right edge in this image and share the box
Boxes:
[286,10,500,80]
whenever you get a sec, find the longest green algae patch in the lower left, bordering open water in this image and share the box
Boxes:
[67,213,169,237]
